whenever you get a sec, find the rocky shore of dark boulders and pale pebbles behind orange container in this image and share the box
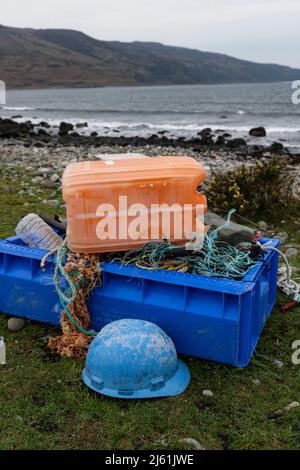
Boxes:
[0,118,300,202]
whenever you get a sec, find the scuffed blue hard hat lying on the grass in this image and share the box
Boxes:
[82,319,190,398]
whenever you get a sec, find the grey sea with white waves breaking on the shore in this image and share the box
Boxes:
[0,82,300,151]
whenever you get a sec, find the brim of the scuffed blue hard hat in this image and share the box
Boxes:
[82,359,190,399]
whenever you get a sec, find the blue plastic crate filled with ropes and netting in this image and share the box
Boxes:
[0,237,280,367]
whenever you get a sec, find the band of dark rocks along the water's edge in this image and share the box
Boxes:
[0,116,300,162]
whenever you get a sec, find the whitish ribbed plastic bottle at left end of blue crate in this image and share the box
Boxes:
[16,214,62,250]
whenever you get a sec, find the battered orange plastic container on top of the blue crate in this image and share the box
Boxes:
[62,157,207,253]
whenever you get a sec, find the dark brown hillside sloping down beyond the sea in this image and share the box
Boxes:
[0,25,300,88]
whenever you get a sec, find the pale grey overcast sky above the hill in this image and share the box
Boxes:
[0,0,300,68]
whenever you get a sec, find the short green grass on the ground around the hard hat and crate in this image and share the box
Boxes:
[0,169,300,450]
